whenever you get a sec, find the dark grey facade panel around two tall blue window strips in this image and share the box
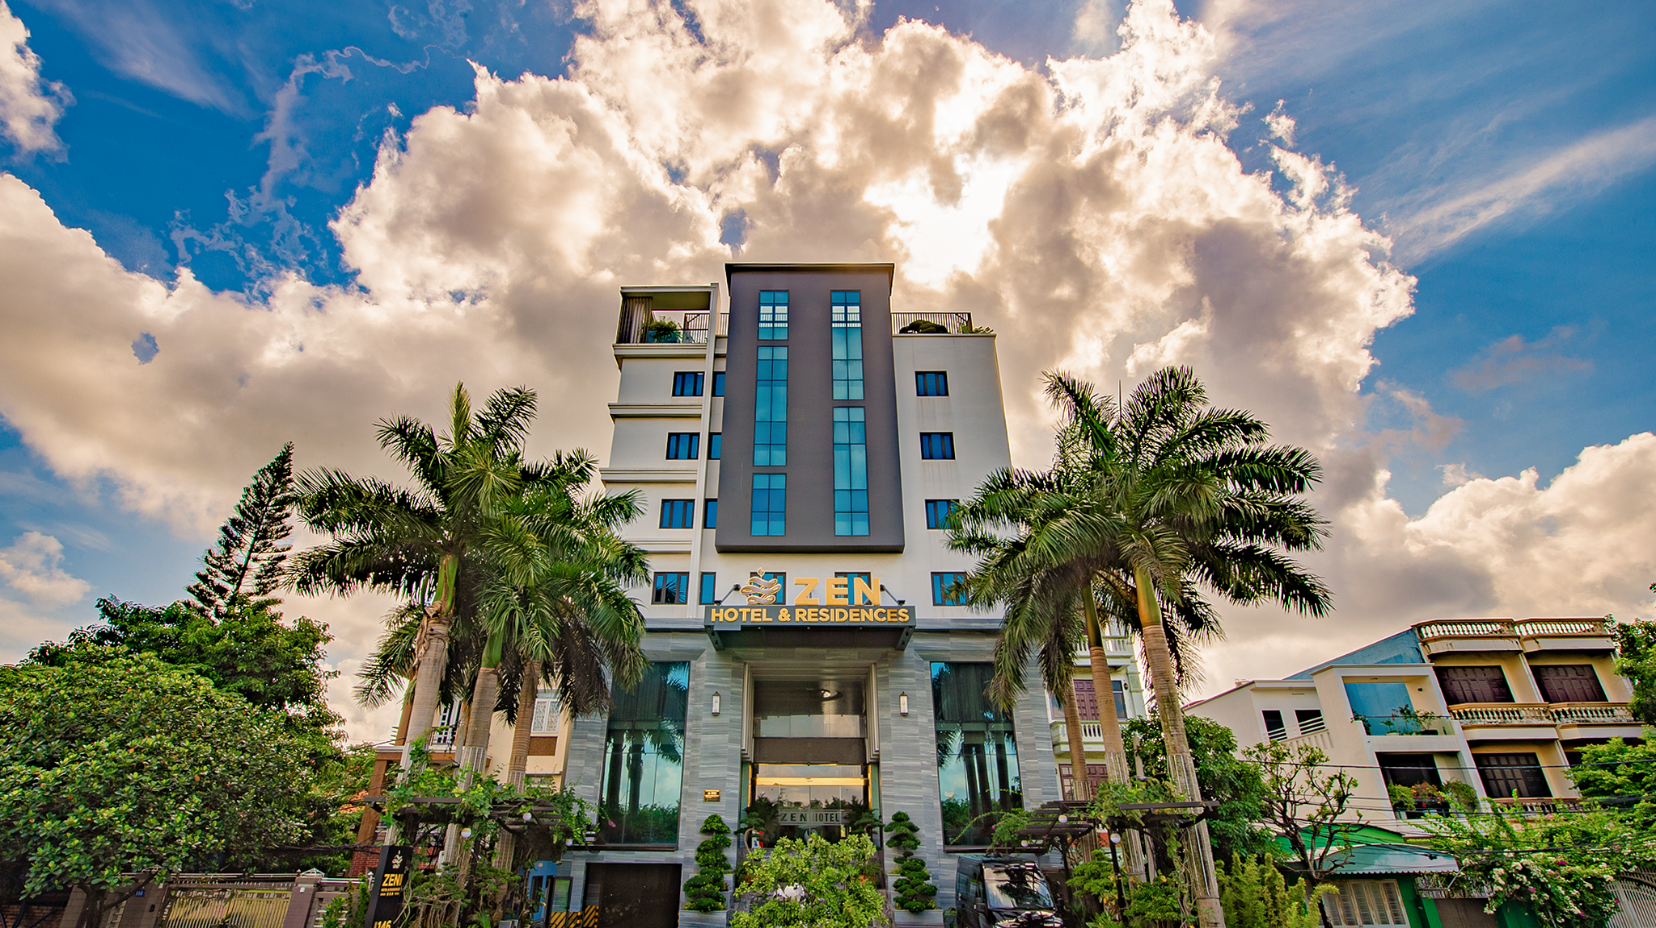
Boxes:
[714,265,903,552]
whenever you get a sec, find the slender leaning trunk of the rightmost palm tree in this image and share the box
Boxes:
[1133,565,1225,928]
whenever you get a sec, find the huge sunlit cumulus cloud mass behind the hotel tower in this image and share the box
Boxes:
[0,0,1649,725]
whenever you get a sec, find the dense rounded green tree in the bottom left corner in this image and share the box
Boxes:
[0,655,313,928]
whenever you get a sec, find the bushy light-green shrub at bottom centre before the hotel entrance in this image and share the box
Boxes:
[730,832,886,928]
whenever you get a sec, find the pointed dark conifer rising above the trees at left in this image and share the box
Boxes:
[185,441,295,620]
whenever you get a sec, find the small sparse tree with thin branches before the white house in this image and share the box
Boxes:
[1242,741,1363,887]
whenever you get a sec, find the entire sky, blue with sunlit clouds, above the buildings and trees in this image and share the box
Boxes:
[0,0,1656,737]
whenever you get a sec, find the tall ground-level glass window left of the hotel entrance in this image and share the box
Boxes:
[598,661,691,847]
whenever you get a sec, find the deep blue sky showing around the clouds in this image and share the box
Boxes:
[0,0,1656,732]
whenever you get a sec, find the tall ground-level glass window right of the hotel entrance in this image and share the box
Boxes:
[927,663,1023,847]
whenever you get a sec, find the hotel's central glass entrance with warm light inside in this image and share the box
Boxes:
[744,669,878,847]
